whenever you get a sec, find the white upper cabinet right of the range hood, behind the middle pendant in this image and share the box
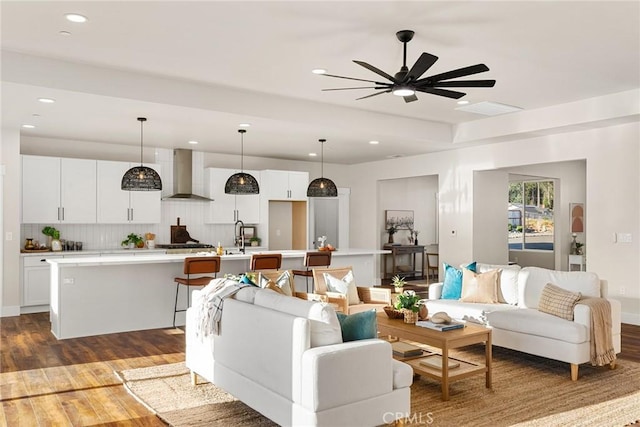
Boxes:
[204,168,263,224]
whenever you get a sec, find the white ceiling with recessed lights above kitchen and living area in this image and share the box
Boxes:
[1,0,640,164]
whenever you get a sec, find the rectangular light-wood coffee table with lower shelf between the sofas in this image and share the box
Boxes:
[377,313,492,400]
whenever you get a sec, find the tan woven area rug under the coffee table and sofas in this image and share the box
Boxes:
[117,346,640,427]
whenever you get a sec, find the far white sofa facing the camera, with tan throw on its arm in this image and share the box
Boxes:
[426,263,621,381]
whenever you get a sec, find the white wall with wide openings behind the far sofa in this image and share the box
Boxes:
[347,122,640,324]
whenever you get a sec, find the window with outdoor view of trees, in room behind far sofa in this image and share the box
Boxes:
[508,181,554,251]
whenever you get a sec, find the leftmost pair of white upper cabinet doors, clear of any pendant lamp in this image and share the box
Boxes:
[22,155,96,224]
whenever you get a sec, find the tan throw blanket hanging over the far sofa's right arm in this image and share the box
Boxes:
[578,297,616,366]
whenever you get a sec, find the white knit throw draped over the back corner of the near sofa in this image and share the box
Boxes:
[194,279,251,340]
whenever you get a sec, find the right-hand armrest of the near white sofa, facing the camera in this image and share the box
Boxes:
[294,339,393,412]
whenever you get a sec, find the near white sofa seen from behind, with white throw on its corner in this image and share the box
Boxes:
[186,287,413,426]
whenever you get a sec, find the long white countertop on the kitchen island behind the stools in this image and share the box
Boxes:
[45,249,391,267]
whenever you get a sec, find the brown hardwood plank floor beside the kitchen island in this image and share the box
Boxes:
[0,313,640,426]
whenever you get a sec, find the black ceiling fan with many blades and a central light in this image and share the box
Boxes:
[321,30,496,102]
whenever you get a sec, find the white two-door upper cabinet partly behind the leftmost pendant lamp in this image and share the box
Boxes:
[97,160,162,224]
